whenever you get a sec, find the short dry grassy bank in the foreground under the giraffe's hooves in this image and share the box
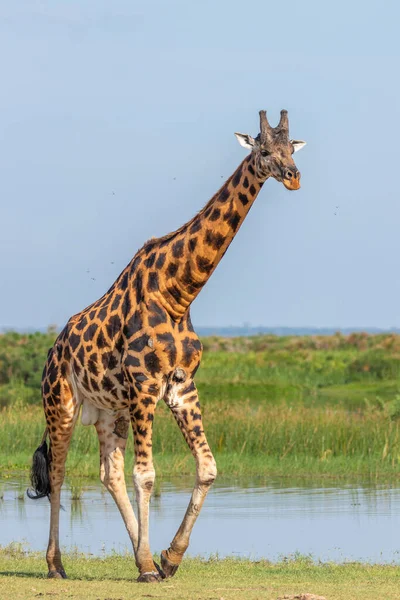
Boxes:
[0,548,400,600]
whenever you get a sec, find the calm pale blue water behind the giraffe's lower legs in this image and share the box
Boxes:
[0,479,400,563]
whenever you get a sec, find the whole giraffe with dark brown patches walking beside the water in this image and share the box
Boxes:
[28,110,305,583]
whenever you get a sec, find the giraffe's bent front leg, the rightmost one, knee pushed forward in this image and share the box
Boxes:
[161,381,217,577]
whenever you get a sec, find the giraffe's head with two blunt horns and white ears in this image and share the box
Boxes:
[235,110,306,190]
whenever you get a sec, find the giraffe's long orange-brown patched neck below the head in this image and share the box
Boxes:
[144,154,263,319]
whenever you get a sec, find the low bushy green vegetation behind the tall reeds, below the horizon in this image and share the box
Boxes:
[0,331,400,408]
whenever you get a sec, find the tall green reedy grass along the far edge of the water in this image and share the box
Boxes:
[0,401,400,479]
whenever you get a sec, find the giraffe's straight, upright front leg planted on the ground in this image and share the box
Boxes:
[129,382,164,583]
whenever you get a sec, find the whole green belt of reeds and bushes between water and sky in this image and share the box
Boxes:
[0,332,400,478]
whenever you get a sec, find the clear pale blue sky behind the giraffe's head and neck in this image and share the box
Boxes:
[0,0,400,328]
